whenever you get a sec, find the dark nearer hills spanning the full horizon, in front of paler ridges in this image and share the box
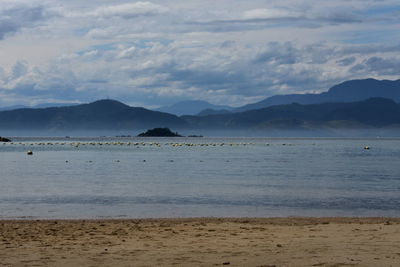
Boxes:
[0,98,400,133]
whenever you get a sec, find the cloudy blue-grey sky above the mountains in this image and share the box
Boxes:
[0,0,400,108]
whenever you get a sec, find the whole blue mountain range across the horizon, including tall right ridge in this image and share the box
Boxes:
[0,79,400,130]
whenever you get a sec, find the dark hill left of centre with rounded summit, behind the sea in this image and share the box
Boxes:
[0,100,187,130]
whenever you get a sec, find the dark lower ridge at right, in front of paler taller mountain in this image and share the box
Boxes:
[181,98,400,129]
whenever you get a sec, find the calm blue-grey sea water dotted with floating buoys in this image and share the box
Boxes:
[0,138,400,219]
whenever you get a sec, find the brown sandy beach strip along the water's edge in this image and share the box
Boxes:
[0,218,400,267]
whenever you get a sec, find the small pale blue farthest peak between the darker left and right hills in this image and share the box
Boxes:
[156,100,233,116]
